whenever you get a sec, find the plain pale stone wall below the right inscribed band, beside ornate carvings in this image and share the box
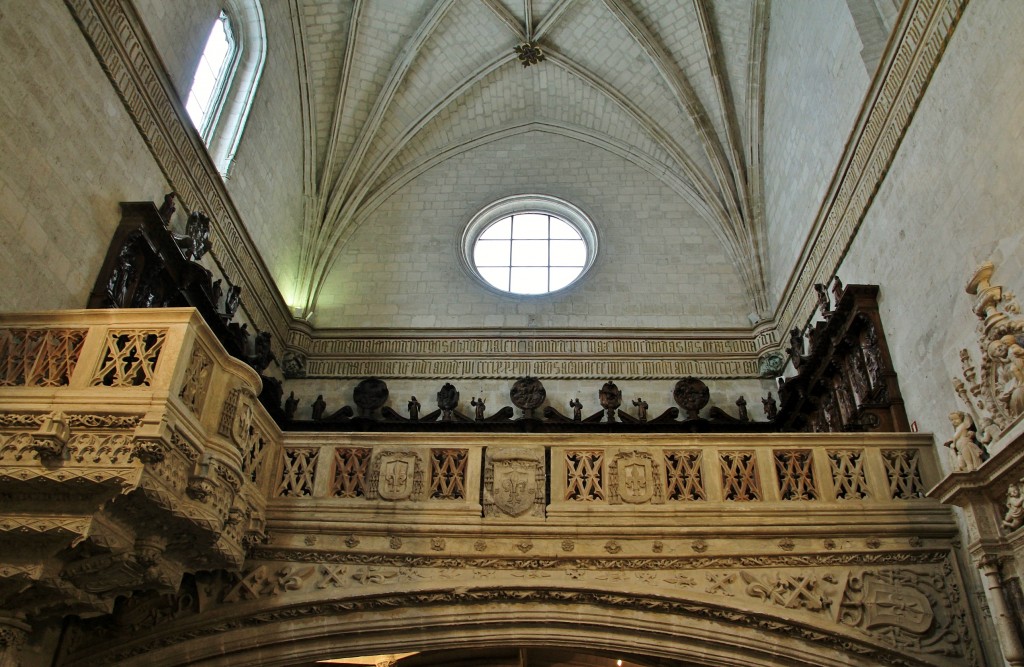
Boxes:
[840,2,1024,456]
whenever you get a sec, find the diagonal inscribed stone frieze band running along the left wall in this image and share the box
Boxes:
[65,0,290,340]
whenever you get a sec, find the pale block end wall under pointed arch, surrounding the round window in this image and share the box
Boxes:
[313,131,752,328]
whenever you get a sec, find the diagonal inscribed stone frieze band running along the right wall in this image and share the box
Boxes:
[763,0,969,351]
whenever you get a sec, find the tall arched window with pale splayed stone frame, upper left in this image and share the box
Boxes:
[185,0,266,175]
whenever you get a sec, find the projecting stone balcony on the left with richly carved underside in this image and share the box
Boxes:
[0,308,280,618]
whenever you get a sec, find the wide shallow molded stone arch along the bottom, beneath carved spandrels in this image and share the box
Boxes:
[58,581,947,667]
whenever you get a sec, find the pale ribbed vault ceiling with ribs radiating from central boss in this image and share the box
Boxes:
[297,0,768,321]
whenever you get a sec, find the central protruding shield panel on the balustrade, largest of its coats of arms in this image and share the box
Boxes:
[483,449,545,517]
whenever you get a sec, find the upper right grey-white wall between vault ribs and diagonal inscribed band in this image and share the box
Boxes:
[763,0,872,302]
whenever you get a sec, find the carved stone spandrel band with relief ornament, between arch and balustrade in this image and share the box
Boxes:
[61,553,981,665]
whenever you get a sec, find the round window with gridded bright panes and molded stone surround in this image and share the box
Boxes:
[463,195,597,295]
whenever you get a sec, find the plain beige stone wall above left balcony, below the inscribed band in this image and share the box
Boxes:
[0,0,168,310]
